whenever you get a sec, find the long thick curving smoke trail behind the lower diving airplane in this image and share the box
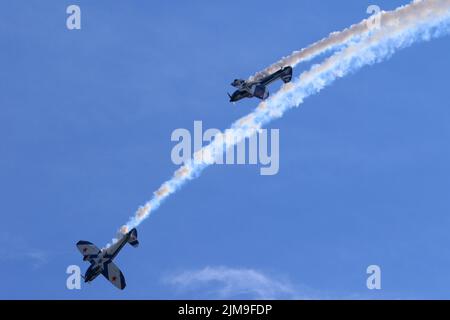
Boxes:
[113,0,450,241]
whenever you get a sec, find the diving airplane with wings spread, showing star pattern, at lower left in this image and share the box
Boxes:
[77,228,139,290]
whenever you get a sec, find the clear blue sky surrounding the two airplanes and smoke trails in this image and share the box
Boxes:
[0,0,450,299]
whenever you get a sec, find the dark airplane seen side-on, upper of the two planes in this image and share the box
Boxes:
[228,66,292,102]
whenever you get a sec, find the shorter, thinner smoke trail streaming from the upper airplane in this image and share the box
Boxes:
[248,0,448,81]
